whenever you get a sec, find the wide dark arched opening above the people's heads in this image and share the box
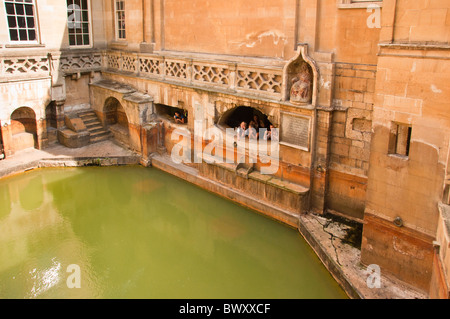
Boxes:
[217,106,272,128]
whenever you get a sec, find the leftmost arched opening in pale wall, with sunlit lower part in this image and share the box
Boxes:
[11,107,39,151]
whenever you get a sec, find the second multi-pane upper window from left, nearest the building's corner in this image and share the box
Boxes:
[67,0,91,47]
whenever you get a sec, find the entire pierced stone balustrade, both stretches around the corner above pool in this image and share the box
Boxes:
[0,50,283,101]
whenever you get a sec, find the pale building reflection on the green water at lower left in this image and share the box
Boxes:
[0,171,101,298]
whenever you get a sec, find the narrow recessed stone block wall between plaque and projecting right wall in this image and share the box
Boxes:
[326,63,377,219]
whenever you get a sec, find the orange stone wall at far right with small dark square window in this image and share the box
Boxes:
[361,1,450,291]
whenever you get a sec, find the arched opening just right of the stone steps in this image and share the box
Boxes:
[103,97,130,146]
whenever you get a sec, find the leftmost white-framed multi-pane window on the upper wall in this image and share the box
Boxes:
[5,0,38,43]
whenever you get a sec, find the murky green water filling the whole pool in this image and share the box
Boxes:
[0,166,346,299]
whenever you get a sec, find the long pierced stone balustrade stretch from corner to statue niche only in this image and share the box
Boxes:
[104,51,283,101]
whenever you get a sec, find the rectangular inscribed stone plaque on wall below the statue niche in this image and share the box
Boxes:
[280,113,310,150]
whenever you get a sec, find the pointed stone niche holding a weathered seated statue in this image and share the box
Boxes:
[284,45,318,106]
